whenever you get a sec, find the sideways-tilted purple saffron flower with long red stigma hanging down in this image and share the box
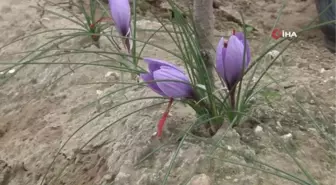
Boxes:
[140,58,193,137]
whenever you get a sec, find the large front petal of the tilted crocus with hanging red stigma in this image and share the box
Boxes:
[153,66,192,98]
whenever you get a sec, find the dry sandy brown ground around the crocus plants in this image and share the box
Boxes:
[0,0,336,185]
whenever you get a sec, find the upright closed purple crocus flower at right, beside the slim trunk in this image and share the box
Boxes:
[216,32,251,90]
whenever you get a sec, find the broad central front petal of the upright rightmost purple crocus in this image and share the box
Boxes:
[224,36,244,88]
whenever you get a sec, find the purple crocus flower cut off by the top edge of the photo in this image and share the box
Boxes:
[109,0,132,53]
